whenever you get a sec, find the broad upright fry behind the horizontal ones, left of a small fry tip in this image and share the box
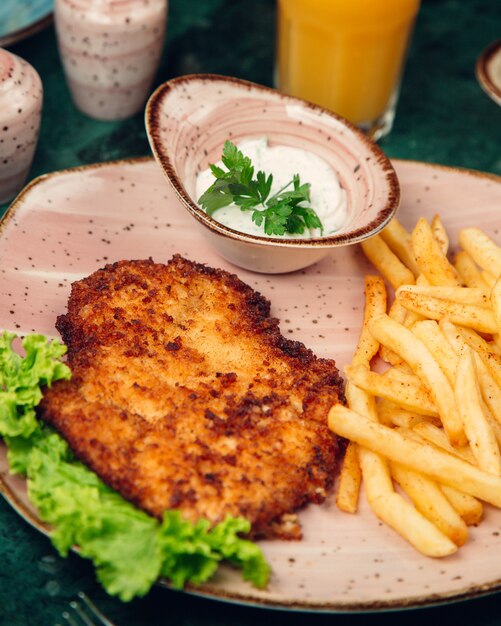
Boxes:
[411,218,461,286]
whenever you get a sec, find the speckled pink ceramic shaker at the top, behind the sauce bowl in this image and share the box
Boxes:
[55,0,167,120]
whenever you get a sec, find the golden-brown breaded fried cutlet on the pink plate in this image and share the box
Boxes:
[40,255,343,538]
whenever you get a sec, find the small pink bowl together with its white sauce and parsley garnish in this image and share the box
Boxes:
[146,74,400,273]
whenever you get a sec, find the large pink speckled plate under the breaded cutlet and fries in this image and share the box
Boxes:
[0,159,501,612]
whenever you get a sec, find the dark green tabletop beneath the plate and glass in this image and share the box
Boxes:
[0,0,501,626]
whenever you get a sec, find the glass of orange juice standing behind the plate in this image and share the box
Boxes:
[277,0,419,139]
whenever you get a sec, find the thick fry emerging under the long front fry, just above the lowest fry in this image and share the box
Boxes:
[390,463,468,546]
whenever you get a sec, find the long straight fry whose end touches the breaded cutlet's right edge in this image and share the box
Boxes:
[328,404,501,507]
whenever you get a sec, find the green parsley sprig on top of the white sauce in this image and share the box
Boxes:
[198,141,323,235]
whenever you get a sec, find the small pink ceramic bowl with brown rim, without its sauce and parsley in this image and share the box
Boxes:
[145,74,400,274]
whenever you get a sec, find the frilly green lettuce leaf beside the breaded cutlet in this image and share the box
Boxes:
[0,332,270,601]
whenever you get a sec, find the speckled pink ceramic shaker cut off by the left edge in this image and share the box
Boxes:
[0,48,43,204]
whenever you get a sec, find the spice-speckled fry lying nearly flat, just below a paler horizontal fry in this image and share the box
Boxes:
[397,289,497,334]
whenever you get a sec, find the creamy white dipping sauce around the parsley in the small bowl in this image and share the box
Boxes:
[196,137,346,239]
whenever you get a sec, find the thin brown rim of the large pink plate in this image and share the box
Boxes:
[0,156,501,614]
